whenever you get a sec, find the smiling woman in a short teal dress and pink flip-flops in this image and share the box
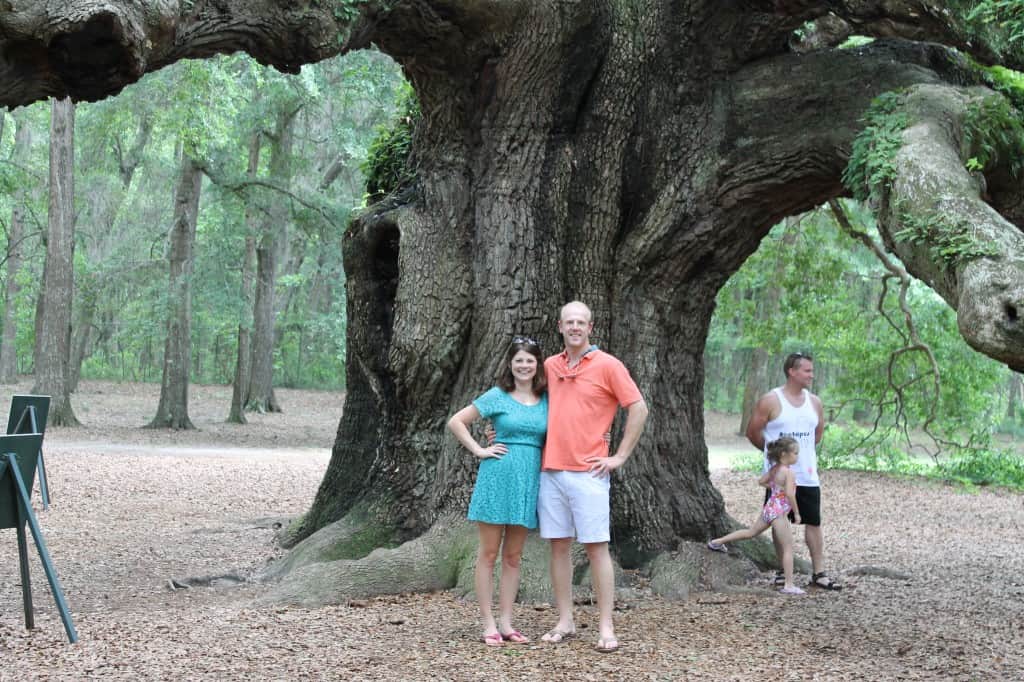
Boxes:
[449,337,548,646]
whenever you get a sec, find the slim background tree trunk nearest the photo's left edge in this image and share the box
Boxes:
[0,110,32,384]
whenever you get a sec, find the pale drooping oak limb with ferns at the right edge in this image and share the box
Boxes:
[878,85,1024,371]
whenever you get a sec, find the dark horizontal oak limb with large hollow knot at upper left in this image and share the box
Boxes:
[0,0,384,106]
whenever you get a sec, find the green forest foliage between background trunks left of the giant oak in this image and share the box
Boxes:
[0,50,403,391]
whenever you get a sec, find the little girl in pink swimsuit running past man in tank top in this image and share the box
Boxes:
[708,436,804,594]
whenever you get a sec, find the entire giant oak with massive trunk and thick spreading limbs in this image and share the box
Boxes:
[0,0,1024,601]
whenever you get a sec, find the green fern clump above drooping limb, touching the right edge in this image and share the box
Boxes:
[964,95,1024,177]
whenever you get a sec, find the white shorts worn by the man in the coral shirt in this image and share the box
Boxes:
[537,471,611,544]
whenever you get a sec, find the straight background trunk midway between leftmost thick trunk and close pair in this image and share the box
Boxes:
[148,152,203,429]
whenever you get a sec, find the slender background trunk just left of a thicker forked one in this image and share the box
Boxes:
[227,132,262,424]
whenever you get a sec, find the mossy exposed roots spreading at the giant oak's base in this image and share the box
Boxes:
[260,513,809,606]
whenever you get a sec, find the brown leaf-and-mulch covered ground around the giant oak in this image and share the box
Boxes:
[0,382,1024,680]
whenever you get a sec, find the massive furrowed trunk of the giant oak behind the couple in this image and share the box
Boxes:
[281,2,1024,598]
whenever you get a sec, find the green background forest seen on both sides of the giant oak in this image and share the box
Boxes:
[0,46,1024,477]
